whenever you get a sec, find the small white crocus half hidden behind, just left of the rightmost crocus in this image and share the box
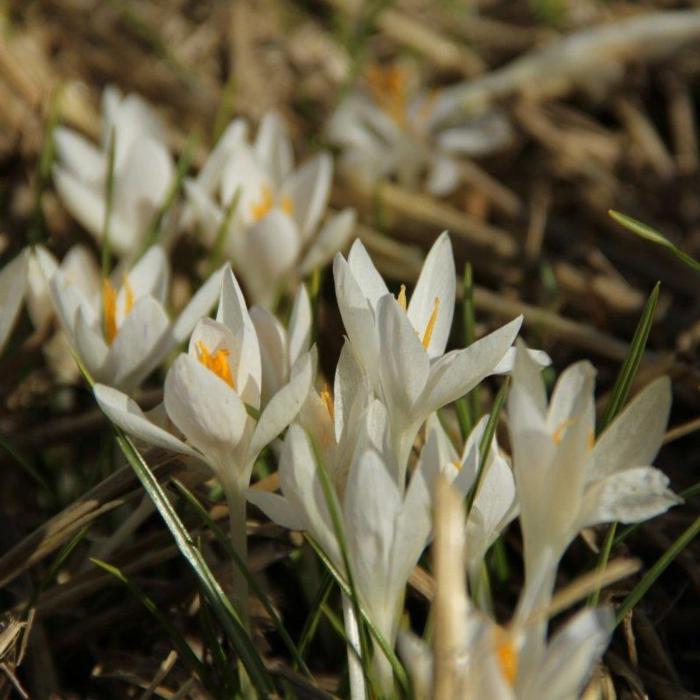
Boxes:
[421,415,517,577]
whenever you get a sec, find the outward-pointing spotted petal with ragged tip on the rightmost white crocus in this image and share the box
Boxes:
[581,467,683,528]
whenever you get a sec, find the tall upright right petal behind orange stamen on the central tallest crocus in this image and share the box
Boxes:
[407,232,457,358]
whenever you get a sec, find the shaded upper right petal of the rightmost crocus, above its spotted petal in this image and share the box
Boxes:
[590,377,671,478]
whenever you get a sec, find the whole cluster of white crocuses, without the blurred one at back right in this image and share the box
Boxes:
[0,87,679,700]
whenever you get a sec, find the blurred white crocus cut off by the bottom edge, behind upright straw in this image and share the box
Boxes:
[399,608,614,700]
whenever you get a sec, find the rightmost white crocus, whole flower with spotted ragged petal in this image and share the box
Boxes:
[508,348,681,638]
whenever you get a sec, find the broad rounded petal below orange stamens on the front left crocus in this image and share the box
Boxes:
[164,355,248,475]
